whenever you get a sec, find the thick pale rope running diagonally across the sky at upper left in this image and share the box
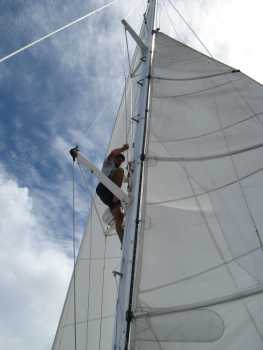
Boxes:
[0,0,118,63]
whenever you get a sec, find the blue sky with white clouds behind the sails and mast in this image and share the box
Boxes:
[0,0,263,350]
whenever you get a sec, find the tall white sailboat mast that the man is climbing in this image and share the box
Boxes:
[113,0,156,350]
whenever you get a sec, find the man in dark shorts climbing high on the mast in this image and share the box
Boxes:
[96,144,129,243]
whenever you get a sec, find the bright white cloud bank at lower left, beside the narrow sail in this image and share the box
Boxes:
[0,167,72,350]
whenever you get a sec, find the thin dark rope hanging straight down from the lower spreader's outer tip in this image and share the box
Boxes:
[72,160,77,350]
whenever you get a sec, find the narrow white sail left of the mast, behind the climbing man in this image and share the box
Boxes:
[52,6,152,350]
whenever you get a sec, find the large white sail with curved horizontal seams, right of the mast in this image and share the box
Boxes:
[130,32,263,350]
